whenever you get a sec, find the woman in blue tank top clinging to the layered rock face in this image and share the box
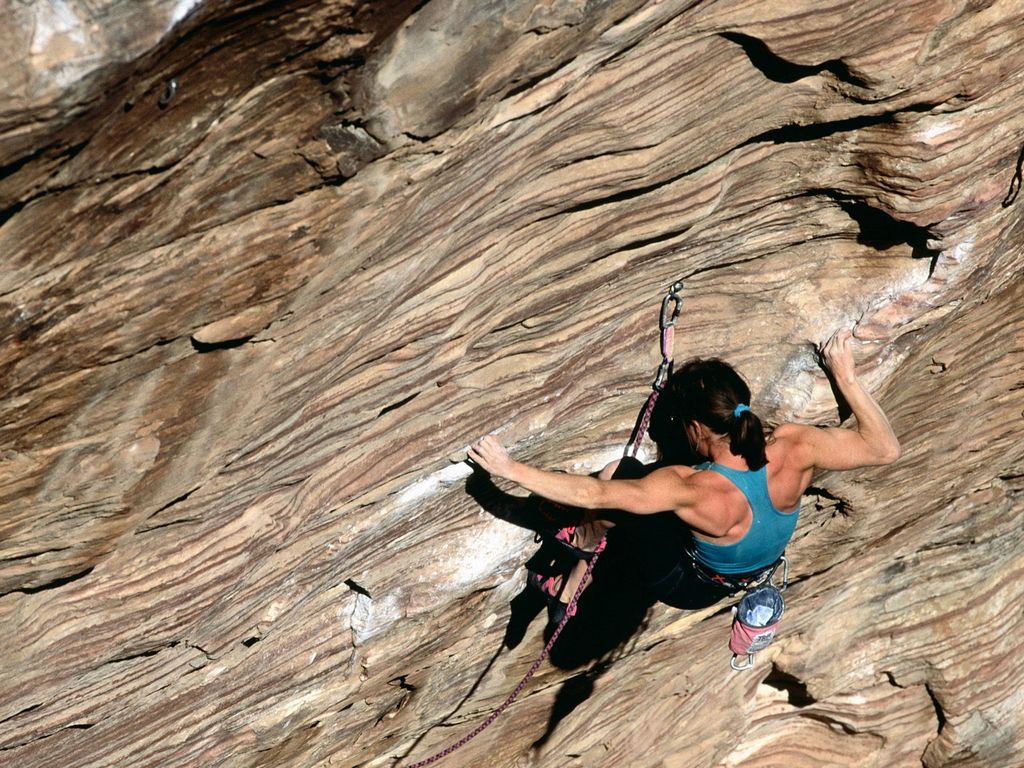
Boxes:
[469,329,900,608]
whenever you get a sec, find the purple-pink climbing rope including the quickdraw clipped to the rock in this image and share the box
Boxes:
[408,281,683,768]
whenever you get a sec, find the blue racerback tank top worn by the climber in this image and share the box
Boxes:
[692,462,800,573]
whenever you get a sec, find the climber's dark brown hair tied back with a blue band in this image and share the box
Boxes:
[668,358,768,470]
